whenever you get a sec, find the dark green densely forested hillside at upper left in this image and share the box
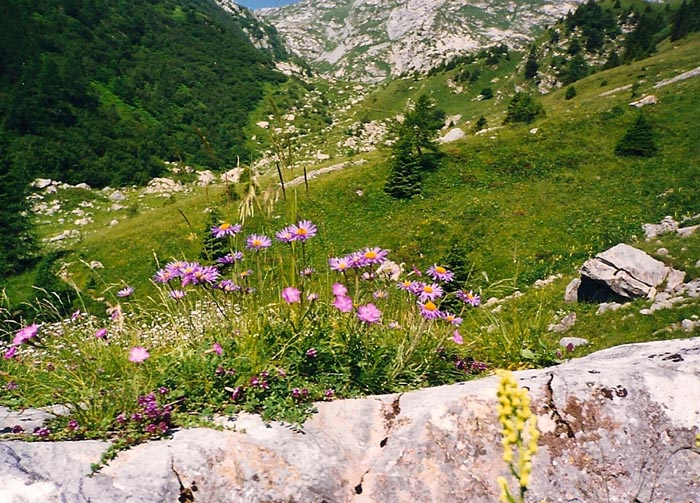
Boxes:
[0,0,284,187]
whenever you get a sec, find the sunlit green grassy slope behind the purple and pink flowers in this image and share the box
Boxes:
[10,36,700,358]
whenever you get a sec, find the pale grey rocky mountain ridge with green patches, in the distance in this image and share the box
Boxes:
[255,0,583,82]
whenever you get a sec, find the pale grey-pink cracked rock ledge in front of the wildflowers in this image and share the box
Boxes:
[0,338,700,503]
